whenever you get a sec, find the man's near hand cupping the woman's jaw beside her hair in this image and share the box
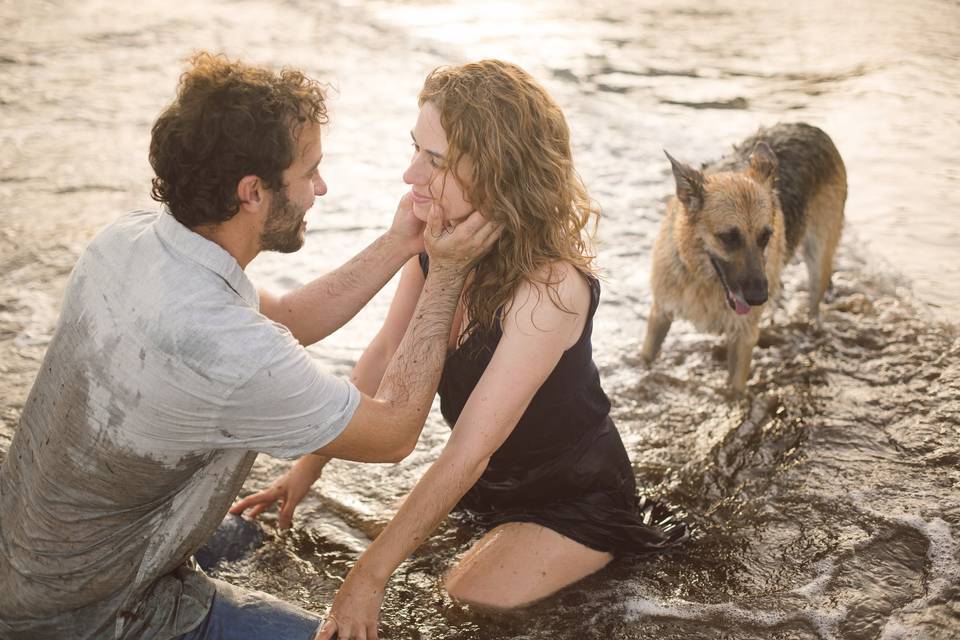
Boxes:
[423,206,502,273]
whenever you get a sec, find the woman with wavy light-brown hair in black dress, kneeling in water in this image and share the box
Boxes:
[233,60,683,640]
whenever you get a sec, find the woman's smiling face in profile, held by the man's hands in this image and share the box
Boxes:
[403,102,473,221]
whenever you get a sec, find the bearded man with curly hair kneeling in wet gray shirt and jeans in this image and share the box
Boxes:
[0,54,496,639]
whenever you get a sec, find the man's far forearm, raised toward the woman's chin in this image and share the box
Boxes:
[262,232,413,346]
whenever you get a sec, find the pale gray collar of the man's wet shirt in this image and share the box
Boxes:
[156,205,260,309]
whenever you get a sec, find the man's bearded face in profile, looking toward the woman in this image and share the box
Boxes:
[260,123,327,253]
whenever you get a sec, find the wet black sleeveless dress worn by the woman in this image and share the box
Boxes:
[420,254,686,554]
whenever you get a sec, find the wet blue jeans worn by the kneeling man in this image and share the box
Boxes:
[180,514,322,640]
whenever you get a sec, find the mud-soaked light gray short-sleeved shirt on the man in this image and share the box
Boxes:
[0,211,360,639]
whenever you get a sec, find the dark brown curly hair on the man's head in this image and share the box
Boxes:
[150,52,327,228]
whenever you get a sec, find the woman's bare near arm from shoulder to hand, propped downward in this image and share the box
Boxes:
[317,267,590,640]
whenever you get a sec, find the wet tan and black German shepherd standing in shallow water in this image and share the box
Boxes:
[641,123,847,393]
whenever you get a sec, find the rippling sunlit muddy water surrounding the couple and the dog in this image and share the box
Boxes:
[0,0,960,639]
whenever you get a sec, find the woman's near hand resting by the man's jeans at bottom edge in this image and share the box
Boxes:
[314,563,386,640]
